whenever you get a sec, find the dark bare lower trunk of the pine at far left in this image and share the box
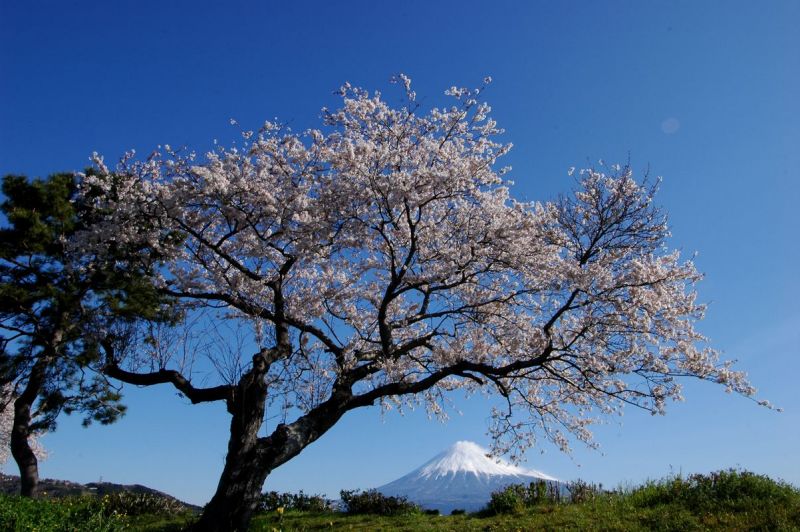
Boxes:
[11,358,47,497]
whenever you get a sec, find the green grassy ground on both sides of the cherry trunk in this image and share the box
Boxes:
[0,471,800,532]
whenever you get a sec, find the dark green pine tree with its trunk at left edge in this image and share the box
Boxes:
[0,174,167,496]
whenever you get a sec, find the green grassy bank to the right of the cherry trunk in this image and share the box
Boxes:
[253,470,800,532]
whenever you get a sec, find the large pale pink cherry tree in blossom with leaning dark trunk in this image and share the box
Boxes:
[79,76,754,530]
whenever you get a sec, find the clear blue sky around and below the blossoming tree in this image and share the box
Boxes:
[0,0,800,503]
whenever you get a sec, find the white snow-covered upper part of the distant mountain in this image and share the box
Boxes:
[419,441,555,480]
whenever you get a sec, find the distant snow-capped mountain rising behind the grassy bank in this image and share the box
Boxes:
[377,441,556,513]
